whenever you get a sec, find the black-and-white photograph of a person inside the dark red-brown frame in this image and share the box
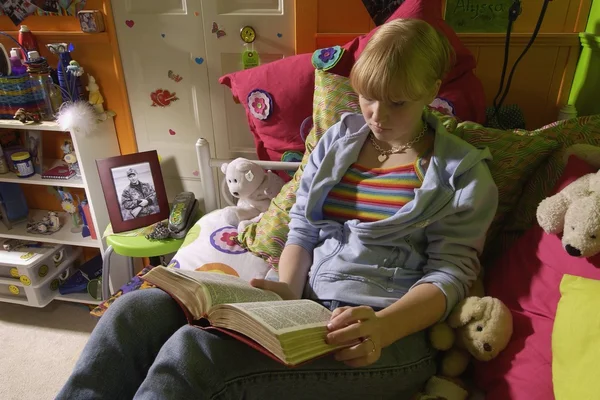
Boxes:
[111,162,160,221]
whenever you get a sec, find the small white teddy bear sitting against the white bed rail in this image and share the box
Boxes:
[221,158,284,232]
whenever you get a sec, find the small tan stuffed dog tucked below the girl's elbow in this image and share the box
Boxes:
[420,296,513,400]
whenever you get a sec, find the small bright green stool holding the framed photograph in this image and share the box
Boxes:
[102,228,185,300]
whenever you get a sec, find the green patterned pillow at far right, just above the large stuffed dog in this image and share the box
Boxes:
[505,115,600,232]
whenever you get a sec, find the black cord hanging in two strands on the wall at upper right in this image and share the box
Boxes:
[488,0,551,129]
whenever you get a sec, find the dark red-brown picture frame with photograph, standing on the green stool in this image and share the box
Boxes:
[96,150,169,233]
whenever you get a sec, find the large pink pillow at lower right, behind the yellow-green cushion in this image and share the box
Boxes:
[474,156,600,400]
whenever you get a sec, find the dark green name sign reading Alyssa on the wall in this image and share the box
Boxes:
[445,0,513,33]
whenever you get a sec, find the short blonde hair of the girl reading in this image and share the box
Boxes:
[350,19,454,103]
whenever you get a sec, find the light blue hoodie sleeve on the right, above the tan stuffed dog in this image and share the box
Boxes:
[413,162,498,319]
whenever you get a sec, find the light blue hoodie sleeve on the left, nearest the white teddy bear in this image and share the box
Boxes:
[286,117,346,254]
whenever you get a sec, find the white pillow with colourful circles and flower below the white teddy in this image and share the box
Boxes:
[169,210,271,281]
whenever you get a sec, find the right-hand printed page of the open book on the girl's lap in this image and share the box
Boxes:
[220,300,331,336]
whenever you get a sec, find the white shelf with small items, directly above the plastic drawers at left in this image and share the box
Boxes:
[0,210,101,248]
